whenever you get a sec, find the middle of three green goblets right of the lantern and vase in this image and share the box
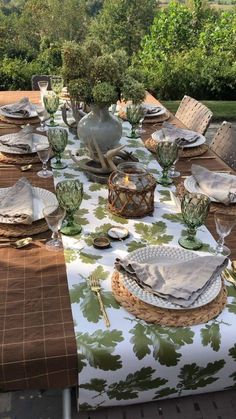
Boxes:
[156,141,179,186]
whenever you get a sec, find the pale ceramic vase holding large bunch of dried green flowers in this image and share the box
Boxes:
[63,40,145,152]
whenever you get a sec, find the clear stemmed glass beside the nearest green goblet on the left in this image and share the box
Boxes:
[43,205,66,251]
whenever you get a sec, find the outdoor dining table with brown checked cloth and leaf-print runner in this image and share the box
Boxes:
[0,92,236,416]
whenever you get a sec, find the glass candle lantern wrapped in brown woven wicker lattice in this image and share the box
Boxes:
[108,162,156,218]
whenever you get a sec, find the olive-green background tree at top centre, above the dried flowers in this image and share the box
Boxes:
[89,0,157,57]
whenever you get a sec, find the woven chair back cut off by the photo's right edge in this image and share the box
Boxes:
[210,121,236,170]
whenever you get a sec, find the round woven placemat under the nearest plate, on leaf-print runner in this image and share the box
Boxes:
[112,271,227,327]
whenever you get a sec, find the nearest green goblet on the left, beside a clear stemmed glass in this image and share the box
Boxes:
[56,180,83,236]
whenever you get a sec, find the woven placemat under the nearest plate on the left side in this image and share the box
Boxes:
[0,219,48,237]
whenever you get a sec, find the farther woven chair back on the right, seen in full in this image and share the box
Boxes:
[175,96,213,134]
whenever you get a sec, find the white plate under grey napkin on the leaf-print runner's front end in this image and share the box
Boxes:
[119,246,221,310]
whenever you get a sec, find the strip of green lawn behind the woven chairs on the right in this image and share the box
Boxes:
[161,100,236,122]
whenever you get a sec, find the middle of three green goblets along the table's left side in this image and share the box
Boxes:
[48,128,68,169]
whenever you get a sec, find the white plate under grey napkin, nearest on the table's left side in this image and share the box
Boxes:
[0,186,58,224]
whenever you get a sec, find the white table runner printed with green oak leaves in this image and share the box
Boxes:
[54,115,236,410]
